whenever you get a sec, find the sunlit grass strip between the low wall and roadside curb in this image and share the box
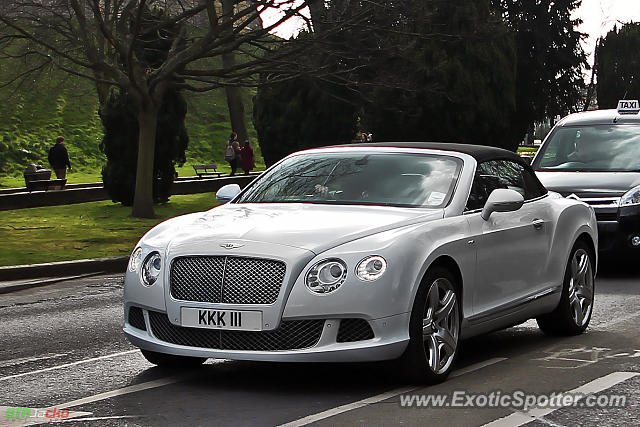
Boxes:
[0,193,217,266]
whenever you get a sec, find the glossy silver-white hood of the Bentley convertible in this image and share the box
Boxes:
[143,203,444,254]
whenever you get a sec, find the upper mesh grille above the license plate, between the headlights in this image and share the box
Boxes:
[170,256,286,304]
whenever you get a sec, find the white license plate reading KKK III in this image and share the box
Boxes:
[182,307,262,331]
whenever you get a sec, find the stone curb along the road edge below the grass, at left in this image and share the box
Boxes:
[0,255,129,282]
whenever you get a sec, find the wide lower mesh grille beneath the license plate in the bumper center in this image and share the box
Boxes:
[149,311,324,351]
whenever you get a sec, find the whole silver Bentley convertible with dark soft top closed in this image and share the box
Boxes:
[124,143,598,383]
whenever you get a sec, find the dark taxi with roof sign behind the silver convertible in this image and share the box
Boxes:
[532,101,640,255]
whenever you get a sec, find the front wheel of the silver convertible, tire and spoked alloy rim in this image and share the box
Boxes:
[399,267,460,384]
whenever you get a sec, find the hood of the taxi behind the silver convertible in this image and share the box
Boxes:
[536,171,640,197]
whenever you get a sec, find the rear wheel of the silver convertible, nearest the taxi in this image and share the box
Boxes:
[536,241,595,336]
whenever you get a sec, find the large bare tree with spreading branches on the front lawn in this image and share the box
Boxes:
[0,0,344,217]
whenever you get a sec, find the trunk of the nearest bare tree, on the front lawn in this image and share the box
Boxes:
[132,108,158,218]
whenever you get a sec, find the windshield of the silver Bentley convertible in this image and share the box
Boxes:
[236,150,462,208]
